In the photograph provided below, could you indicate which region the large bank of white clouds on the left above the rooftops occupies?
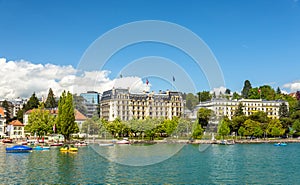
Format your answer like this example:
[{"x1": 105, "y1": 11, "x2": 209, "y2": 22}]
[{"x1": 0, "y1": 58, "x2": 150, "y2": 99}]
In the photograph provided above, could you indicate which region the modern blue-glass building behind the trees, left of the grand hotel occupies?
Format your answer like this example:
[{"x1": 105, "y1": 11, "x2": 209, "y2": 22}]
[{"x1": 80, "y1": 91, "x2": 100, "y2": 118}]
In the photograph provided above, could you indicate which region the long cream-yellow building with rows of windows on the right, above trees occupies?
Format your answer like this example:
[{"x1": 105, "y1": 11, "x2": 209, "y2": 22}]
[{"x1": 194, "y1": 99, "x2": 289, "y2": 119}]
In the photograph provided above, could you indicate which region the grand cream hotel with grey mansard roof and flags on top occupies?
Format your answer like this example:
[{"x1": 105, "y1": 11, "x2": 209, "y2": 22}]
[{"x1": 100, "y1": 88, "x2": 183, "y2": 121}]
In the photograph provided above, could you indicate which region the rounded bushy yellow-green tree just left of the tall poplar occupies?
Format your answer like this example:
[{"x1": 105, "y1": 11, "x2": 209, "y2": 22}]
[{"x1": 25, "y1": 105, "x2": 55, "y2": 137}]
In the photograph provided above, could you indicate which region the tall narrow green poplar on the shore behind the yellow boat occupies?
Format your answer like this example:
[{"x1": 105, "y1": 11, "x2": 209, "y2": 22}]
[{"x1": 56, "y1": 91, "x2": 79, "y2": 140}]
